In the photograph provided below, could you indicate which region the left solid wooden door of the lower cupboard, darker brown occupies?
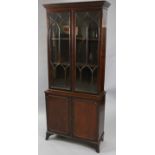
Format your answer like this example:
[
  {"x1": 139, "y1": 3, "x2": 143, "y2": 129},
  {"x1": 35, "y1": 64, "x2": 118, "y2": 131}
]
[{"x1": 46, "y1": 95, "x2": 69, "y2": 134}]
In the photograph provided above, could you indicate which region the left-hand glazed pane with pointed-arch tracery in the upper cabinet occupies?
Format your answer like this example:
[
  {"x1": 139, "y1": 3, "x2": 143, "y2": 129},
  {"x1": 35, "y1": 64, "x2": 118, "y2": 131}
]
[{"x1": 48, "y1": 12, "x2": 70, "y2": 89}]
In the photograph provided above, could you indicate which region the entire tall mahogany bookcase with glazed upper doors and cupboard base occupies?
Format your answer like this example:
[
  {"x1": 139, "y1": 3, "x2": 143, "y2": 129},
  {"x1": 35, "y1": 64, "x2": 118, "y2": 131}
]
[{"x1": 44, "y1": 1, "x2": 110, "y2": 152}]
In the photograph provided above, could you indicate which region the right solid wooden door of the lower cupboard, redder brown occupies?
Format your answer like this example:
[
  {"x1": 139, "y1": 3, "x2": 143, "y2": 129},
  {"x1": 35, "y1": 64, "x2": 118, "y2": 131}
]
[{"x1": 73, "y1": 99, "x2": 97, "y2": 140}]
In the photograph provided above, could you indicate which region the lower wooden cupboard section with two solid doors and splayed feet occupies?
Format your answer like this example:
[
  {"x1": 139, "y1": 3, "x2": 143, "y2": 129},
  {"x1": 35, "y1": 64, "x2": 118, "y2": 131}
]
[{"x1": 45, "y1": 91, "x2": 105, "y2": 152}]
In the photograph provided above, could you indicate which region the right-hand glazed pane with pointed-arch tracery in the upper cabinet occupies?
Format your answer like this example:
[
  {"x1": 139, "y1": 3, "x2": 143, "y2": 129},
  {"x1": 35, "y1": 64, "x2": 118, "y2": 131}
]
[{"x1": 75, "y1": 11, "x2": 99, "y2": 93}]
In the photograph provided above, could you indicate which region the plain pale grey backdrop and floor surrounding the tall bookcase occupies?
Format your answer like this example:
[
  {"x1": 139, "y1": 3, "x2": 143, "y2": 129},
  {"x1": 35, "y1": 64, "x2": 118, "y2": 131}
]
[{"x1": 38, "y1": 0, "x2": 116, "y2": 155}]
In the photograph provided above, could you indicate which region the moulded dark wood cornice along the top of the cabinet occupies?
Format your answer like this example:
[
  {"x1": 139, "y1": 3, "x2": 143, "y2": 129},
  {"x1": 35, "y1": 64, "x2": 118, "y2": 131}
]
[{"x1": 43, "y1": 1, "x2": 110, "y2": 9}]
